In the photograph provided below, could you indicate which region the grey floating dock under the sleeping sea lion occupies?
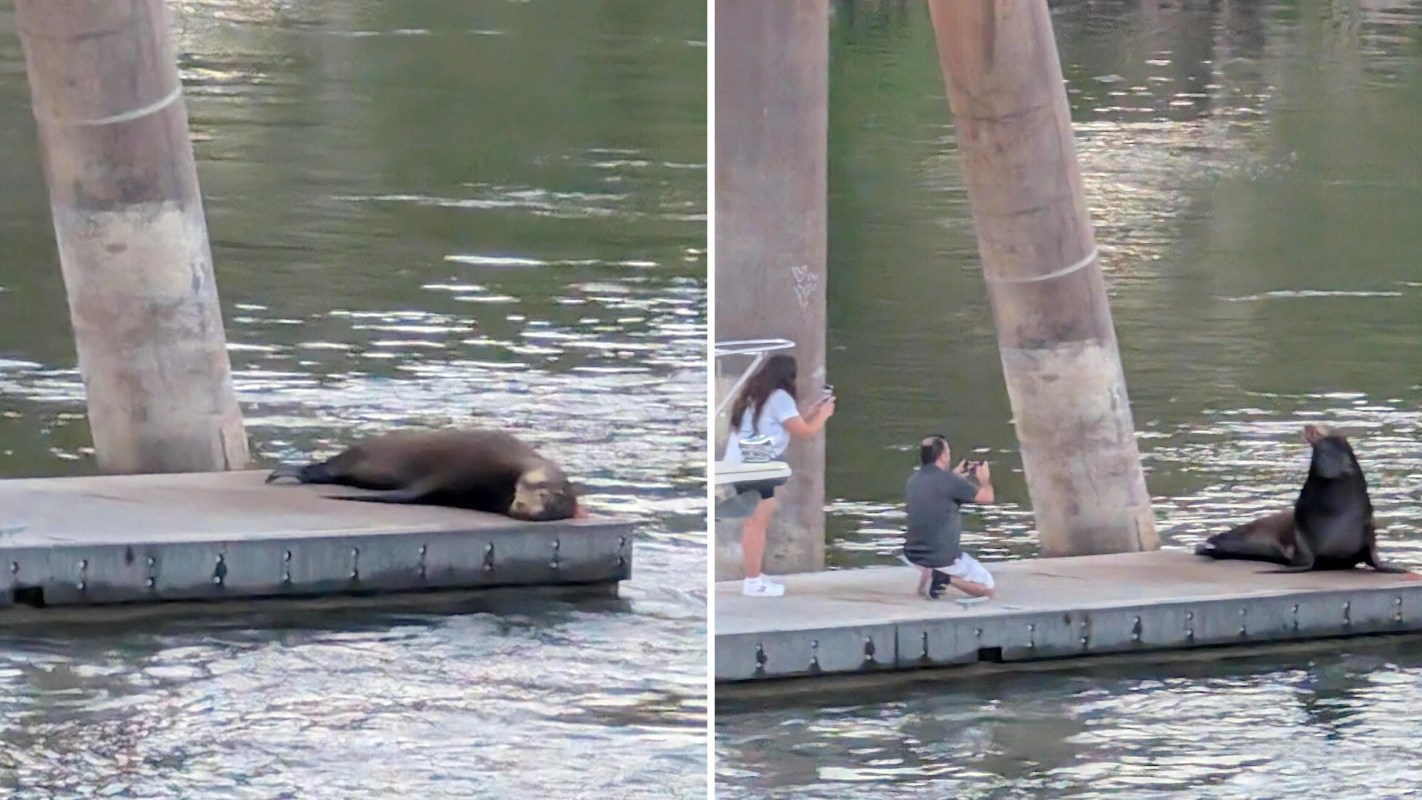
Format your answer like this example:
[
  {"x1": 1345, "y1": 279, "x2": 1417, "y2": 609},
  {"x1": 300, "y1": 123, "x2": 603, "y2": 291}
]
[{"x1": 0, "y1": 472, "x2": 633, "y2": 611}]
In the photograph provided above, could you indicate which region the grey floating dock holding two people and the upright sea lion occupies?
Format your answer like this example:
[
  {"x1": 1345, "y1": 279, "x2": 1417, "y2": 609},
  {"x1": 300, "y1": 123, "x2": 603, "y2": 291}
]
[{"x1": 715, "y1": 550, "x2": 1422, "y2": 683}]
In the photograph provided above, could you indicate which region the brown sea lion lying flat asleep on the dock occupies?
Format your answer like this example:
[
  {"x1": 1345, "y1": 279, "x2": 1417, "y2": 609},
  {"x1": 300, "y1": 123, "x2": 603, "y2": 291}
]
[{"x1": 266, "y1": 429, "x2": 587, "y2": 521}]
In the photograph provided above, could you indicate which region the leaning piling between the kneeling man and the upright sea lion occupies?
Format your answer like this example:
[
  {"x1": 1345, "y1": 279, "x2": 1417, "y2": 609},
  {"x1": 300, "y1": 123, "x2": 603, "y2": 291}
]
[{"x1": 929, "y1": 0, "x2": 1159, "y2": 556}]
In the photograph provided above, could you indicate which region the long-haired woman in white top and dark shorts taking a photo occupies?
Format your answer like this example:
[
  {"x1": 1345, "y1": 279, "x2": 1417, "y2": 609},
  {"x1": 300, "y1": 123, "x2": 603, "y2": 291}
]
[{"x1": 725, "y1": 354, "x2": 835, "y2": 597}]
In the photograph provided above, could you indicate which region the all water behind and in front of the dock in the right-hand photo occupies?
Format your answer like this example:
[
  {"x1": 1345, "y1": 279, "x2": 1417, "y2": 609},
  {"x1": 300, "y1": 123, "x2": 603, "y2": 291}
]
[{"x1": 717, "y1": 0, "x2": 1422, "y2": 799}]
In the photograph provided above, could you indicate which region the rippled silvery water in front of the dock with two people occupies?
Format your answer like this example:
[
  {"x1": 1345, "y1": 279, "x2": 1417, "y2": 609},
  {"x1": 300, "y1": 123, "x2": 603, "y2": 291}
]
[{"x1": 717, "y1": 641, "x2": 1422, "y2": 799}]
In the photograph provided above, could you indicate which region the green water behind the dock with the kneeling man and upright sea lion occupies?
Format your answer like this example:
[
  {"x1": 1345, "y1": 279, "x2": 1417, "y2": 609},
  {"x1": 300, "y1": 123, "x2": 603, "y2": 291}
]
[{"x1": 826, "y1": 1, "x2": 1422, "y2": 566}]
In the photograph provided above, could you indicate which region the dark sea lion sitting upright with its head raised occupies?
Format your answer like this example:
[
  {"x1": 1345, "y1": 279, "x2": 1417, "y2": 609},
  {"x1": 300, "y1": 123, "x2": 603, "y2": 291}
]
[{"x1": 1194, "y1": 423, "x2": 1409, "y2": 573}]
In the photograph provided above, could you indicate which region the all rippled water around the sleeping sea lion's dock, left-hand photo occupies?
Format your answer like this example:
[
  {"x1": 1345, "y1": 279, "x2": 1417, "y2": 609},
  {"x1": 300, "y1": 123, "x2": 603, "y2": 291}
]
[{"x1": 0, "y1": 0, "x2": 707, "y2": 799}]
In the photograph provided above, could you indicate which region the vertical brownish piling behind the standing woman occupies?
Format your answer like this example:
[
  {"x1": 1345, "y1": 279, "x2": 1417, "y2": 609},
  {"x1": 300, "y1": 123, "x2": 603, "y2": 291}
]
[{"x1": 715, "y1": 0, "x2": 833, "y2": 580}]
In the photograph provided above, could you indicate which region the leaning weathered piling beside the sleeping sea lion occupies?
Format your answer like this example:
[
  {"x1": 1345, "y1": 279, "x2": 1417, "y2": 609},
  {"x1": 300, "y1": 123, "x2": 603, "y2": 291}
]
[{"x1": 16, "y1": 0, "x2": 247, "y2": 473}]
